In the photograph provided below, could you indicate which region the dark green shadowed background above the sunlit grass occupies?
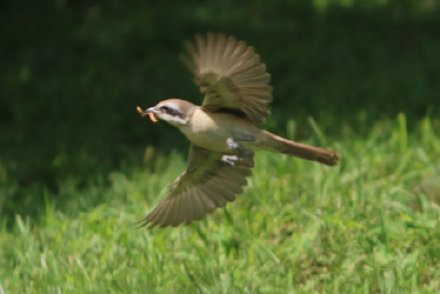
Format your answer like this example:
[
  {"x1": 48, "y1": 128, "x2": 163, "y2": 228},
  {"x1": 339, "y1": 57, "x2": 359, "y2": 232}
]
[{"x1": 0, "y1": 0, "x2": 440, "y2": 224}]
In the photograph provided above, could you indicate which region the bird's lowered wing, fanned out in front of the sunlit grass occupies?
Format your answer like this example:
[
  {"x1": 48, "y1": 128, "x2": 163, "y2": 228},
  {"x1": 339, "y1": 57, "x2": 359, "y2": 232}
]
[{"x1": 141, "y1": 145, "x2": 254, "y2": 227}]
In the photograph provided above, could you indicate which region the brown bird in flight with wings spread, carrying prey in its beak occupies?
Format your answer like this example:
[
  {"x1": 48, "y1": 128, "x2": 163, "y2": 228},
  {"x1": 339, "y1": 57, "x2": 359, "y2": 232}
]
[{"x1": 137, "y1": 33, "x2": 340, "y2": 228}]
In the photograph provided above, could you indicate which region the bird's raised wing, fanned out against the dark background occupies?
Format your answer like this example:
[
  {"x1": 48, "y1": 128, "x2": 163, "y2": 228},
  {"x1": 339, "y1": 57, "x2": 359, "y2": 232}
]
[{"x1": 183, "y1": 34, "x2": 272, "y2": 123}]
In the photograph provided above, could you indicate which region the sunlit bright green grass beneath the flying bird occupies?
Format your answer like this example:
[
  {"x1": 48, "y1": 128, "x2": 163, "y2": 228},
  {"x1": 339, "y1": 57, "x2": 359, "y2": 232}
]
[{"x1": 0, "y1": 115, "x2": 440, "y2": 293}]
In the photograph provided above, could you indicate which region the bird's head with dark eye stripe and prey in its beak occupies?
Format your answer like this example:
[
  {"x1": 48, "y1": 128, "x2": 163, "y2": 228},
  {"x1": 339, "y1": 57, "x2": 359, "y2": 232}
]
[{"x1": 137, "y1": 98, "x2": 194, "y2": 127}]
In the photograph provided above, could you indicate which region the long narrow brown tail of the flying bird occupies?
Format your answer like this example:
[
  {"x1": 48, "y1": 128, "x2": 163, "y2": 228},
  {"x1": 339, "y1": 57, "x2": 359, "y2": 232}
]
[{"x1": 261, "y1": 131, "x2": 340, "y2": 165}]
